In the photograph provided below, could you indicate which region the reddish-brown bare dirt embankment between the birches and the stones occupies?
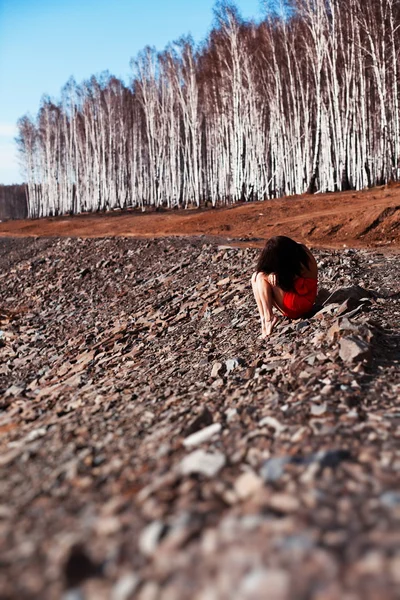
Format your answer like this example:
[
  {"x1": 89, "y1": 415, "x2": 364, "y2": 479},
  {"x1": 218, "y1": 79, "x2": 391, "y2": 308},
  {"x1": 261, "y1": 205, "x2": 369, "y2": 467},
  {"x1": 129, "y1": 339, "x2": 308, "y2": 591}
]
[{"x1": 0, "y1": 184, "x2": 400, "y2": 247}]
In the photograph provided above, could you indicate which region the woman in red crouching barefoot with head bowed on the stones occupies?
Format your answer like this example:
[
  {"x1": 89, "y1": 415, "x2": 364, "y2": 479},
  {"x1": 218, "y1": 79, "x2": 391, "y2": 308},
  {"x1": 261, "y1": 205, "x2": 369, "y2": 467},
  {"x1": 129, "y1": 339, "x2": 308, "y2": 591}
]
[{"x1": 251, "y1": 235, "x2": 318, "y2": 338}]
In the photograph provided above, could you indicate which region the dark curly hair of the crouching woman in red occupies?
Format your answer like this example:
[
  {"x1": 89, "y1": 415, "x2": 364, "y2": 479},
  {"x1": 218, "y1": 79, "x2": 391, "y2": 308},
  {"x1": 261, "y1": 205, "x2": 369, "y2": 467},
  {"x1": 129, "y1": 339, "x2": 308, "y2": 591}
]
[{"x1": 257, "y1": 235, "x2": 310, "y2": 292}]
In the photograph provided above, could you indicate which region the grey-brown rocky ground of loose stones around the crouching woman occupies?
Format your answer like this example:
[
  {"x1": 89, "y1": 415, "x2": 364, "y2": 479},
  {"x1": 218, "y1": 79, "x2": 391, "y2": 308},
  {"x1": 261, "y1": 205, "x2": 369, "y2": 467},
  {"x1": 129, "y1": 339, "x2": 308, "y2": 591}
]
[{"x1": 0, "y1": 238, "x2": 400, "y2": 600}]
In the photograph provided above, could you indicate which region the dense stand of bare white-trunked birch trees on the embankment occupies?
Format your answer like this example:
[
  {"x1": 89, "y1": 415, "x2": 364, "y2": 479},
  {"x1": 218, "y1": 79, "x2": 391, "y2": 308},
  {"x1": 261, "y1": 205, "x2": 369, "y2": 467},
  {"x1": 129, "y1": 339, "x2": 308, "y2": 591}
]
[{"x1": 18, "y1": 0, "x2": 400, "y2": 217}]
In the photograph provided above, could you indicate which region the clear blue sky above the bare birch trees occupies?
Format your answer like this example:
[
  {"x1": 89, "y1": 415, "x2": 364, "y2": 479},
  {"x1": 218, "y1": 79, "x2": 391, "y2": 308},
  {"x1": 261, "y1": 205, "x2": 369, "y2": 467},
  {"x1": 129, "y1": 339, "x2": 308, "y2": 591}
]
[{"x1": 0, "y1": 0, "x2": 262, "y2": 184}]
